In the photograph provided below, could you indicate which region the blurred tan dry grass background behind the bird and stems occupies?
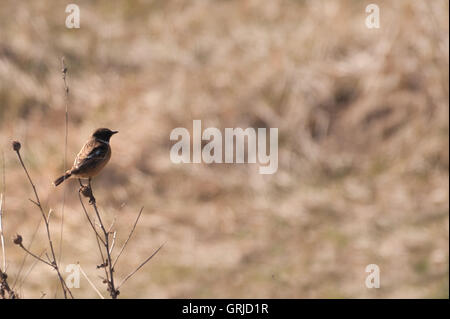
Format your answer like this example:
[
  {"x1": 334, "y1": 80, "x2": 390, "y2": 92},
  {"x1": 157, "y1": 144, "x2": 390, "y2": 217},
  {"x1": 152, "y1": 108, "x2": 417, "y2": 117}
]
[{"x1": 0, "y1": 0, "x2": 449, "y2": 298}]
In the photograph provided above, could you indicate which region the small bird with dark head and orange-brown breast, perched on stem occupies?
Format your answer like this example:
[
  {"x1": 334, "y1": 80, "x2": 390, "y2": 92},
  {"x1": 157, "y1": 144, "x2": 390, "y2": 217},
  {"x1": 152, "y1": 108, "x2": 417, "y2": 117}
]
[{"x1": 53, "y1": 128, "x2": 118, "y2": 187}]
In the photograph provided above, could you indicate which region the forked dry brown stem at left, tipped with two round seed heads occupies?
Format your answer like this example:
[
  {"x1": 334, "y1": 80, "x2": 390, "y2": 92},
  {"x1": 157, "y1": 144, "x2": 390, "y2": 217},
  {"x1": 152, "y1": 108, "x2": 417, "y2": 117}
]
[{"x1": 14, "y1": 149, "x2": 73, "y2": 299}]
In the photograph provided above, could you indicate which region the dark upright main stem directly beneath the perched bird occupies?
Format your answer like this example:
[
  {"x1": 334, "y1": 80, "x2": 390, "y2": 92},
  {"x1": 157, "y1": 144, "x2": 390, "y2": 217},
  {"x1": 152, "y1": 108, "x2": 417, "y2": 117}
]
[{"x1": 79, "y1": 179, "x2": 119, "y2": 299}]
